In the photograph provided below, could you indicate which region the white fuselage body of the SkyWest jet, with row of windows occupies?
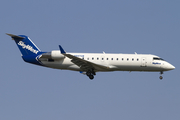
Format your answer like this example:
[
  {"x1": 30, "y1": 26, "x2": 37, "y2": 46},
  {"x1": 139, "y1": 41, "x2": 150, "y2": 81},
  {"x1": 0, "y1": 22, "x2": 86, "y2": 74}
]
[{"x1": 40, "y1": 51, "x2": 174, "y2": 72}]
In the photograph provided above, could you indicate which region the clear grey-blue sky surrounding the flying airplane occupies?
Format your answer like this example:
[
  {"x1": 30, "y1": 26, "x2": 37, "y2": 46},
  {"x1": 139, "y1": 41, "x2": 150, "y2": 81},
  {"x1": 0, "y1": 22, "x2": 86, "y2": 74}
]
[{"x1": 0, "y1": 0, "x2": 180, "y2": 120}]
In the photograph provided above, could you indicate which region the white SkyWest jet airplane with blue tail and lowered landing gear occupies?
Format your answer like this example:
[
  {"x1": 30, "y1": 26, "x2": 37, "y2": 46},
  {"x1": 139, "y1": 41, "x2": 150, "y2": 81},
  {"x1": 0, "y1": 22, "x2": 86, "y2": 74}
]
[{"x1": 6, "y1": 33, "x2": 175, "y2": 80}]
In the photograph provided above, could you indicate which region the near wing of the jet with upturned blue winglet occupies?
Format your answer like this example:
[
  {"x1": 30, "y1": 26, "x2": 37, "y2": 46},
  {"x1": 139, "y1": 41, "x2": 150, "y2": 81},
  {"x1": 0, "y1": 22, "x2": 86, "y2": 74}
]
[{"x1": 59, "y1": 45, "x2": 109, "y2": 71}]
